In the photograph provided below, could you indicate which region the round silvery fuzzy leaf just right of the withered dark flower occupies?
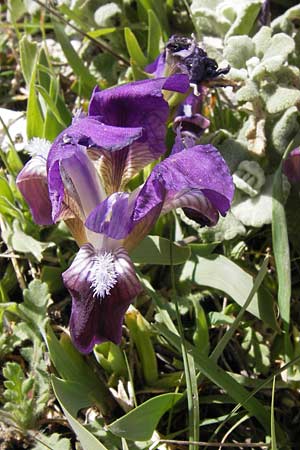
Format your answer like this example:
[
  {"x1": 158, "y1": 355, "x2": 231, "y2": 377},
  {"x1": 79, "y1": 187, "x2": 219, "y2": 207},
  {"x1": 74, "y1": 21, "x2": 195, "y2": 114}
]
[{"x1": 224, "y1": 36, "x2": 255, "y2": 69}]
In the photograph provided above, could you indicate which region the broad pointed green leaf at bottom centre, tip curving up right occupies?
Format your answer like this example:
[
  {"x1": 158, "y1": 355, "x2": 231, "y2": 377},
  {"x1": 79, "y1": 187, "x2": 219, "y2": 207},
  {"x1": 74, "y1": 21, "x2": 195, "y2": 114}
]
[{"x1": 108, "y1": 393, "x2": 182, "y2": 441}]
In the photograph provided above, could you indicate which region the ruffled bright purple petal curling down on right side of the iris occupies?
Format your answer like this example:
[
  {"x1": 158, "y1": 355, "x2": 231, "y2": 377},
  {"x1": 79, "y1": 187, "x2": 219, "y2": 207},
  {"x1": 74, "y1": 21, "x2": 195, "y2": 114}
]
[{"x1": 133, "y1": 145, "x2": 234, "y2": 224}]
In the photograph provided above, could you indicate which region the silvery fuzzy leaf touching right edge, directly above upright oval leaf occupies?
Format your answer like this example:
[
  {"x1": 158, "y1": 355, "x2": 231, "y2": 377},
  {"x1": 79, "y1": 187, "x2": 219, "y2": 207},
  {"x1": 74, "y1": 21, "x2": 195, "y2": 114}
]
[{"x1": 262, "y1": 86, "x2": 300, "y2": 114}]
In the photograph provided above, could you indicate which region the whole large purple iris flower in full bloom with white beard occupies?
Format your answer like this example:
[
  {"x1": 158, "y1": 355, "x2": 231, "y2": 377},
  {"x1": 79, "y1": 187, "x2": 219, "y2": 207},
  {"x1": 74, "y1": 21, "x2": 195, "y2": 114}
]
[{"x1": 17, "y1": 75, "x2": 233, "y2": 353}]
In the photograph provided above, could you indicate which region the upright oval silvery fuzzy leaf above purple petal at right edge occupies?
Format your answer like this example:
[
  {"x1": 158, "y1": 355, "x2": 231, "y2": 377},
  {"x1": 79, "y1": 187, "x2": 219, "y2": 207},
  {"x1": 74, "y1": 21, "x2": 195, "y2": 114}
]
[{"x1": 271, "y1": 106, "x2": 299, "y2": 155}]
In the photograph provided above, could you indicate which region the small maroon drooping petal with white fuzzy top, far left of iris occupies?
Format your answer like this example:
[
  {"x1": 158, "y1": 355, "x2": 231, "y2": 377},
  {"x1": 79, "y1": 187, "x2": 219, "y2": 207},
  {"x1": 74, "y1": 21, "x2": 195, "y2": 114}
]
[{"x1": 17, "y1": 156, "x2": 53, "y2": 225}]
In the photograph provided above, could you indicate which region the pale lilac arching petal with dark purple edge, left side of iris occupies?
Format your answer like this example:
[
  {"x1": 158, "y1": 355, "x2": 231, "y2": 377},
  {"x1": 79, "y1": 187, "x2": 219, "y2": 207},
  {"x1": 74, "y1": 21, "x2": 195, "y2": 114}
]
[{"x1": 47, "y1": 137, "x2": 105, "y2": 221}]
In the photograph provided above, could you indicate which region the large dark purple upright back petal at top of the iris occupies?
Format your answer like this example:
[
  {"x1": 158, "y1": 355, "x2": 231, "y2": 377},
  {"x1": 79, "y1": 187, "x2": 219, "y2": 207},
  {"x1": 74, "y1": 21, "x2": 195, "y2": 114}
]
[{"x1": 86, "y1": 74, "x2": 189, "y2": 194}]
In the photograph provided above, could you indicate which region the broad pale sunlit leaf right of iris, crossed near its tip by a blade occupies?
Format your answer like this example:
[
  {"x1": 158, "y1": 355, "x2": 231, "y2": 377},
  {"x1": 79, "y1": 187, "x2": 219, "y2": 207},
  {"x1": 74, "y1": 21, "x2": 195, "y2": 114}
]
[{"x1": 181, "y1": 254, "x2": 278, "y2": 330}]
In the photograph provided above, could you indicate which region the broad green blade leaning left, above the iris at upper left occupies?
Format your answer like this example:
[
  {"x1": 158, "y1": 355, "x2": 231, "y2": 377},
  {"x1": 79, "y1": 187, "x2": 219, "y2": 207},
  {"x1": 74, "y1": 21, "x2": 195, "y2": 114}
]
[{"x1": 52, "y1": 19, "x2": 97, "y2": 98}]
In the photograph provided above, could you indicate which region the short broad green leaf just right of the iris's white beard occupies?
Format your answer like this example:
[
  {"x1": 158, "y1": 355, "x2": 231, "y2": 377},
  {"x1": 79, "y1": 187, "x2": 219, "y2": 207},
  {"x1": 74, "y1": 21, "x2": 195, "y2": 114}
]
[{"x1": 130, "y1": 236, "x2": 191, "y2": 265}]
